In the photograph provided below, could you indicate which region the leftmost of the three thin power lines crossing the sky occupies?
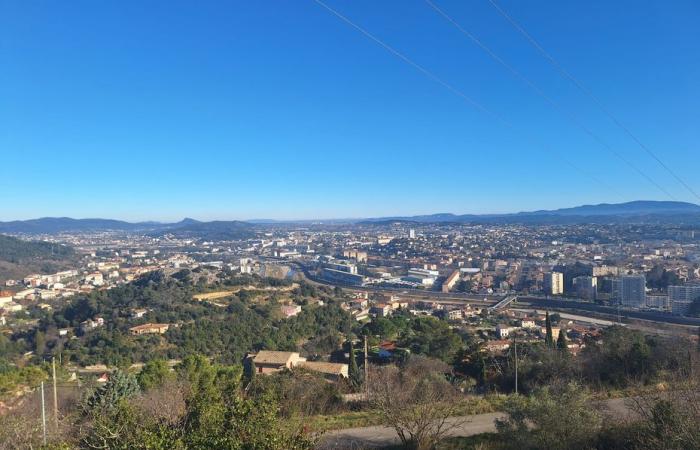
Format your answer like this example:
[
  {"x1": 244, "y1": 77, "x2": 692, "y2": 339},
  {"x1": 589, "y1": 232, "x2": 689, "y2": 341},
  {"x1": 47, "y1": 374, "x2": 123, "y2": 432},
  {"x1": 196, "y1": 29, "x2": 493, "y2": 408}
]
[{"x1": 314, "y1": 0, "x2": 624, "y2": 198}]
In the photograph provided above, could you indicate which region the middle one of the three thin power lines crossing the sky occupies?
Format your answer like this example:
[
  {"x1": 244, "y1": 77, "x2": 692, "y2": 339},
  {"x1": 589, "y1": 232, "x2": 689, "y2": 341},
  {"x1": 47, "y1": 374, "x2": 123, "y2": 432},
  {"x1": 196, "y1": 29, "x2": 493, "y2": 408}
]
[{"x1": 425, "y1": 0, "x2": 675, "y2": 200}]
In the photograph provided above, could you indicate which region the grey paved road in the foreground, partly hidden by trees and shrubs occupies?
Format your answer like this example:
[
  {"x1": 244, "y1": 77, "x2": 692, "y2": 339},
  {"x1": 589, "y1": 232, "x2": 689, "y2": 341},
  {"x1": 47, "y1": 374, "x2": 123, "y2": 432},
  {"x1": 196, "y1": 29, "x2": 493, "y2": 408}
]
[{"x1": 318, "y1": 399, "x2": 633, "y2": 450}]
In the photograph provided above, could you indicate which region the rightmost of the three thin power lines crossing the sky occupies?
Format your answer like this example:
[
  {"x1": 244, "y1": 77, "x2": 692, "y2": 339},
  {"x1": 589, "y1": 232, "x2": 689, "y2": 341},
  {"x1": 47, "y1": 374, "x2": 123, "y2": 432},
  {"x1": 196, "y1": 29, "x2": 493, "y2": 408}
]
[{"x1": 488, "y1": 0, "x2": 700, "y2": 200}]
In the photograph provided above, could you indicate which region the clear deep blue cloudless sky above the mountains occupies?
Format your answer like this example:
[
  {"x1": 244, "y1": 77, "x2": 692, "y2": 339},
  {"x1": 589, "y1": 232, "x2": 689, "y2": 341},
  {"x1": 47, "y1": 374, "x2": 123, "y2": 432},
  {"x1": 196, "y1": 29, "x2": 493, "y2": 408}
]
[{"x1": 0, "y1": 0, "x2": 700, "y2": 220}]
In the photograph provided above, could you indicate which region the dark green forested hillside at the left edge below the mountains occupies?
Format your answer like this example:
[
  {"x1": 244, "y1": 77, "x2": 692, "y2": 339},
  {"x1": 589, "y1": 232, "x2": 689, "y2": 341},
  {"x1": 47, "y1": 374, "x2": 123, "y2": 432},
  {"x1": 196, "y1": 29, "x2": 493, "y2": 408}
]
[{"x1": 0, "y1": 234, "x2": 77, "y2": 282}]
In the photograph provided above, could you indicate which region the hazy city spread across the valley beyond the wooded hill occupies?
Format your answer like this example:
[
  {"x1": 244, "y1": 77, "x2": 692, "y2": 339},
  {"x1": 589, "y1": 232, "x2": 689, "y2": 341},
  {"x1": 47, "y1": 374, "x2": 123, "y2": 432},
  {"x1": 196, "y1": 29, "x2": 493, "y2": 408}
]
[{"x1": 0, "y1": 202, "x2": 700, "y2": 324}]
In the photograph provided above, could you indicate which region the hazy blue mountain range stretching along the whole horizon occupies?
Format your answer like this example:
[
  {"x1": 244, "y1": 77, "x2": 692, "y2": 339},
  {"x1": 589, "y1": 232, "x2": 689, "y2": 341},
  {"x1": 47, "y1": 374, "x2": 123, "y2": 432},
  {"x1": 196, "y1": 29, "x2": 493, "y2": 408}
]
[{"x1": 0, "y1": 200, "x2": 700, "y2": 236}]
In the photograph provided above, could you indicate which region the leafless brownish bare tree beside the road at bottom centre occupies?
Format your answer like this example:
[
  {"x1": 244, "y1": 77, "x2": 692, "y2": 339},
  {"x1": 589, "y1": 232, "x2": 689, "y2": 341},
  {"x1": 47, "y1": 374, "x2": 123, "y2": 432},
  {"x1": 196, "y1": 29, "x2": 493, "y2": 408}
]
[{"x1": 369, "y1": 356, "x2": 465, "y2": 450}]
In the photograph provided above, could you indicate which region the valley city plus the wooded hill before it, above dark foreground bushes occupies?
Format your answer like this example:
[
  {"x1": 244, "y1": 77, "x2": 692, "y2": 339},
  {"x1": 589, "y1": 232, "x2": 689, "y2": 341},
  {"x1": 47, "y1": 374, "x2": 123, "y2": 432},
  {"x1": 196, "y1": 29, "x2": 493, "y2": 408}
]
[{"x1": 0, "y1": 208, "x2": 700, "y2": 428}]
